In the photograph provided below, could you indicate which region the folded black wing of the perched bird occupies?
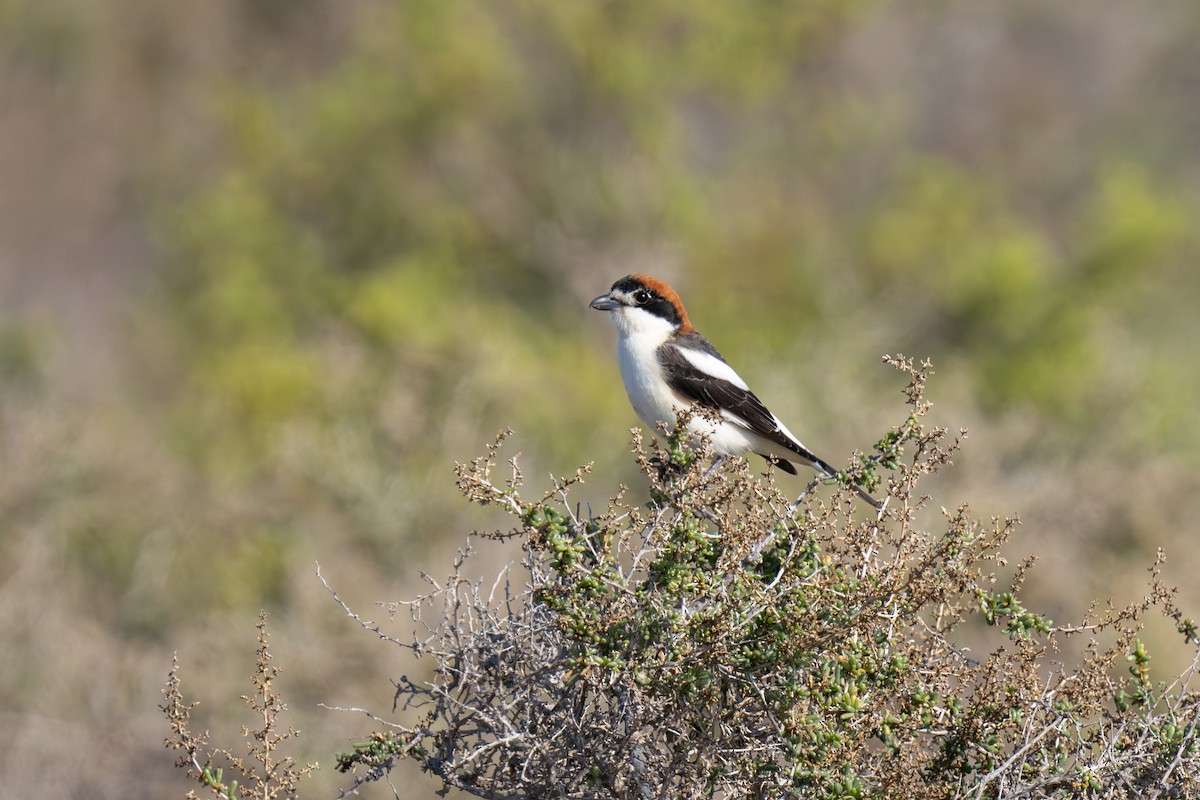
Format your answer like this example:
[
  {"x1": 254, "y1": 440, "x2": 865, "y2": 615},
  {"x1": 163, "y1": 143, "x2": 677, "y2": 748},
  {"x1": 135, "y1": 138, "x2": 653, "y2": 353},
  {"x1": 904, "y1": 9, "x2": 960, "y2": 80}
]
[{"x1": 659, "y1": 331, "x2": 836, "y2": 475}]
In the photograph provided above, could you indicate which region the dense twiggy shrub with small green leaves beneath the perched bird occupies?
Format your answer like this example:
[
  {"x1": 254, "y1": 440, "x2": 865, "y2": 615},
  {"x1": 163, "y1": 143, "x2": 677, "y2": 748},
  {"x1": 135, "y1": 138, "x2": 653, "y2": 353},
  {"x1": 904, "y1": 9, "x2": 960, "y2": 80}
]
[{"x1": 324, "y1": 357, "x2": 1200, "y2": 800}]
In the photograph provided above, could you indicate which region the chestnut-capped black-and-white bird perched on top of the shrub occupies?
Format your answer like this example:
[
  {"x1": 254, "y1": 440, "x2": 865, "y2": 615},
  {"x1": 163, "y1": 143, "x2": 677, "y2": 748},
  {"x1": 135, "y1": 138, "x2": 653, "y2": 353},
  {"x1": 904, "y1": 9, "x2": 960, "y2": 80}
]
[{"x1": 590, "y1": 273, "x2": 883, "y2": 510}]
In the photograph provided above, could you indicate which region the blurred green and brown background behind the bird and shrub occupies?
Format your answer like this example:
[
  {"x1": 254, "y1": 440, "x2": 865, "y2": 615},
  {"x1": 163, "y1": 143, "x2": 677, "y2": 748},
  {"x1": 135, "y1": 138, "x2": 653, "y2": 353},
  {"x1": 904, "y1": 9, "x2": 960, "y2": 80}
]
[{"x1": 0, "y1": 0, "x2": 1200, "y2": 799}]
